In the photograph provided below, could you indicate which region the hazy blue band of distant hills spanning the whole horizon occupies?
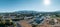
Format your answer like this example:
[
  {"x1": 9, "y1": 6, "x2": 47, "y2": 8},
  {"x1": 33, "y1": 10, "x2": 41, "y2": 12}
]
[{"x1": 0, "y1": 10, "x2": 60, "y2": 14}]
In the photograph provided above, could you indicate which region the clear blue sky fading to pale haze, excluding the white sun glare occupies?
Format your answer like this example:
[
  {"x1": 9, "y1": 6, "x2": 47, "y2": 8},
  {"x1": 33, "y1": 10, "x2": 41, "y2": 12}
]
[{"x1": 0, "y1": 0, "x2": 60, "y2": 12}]
